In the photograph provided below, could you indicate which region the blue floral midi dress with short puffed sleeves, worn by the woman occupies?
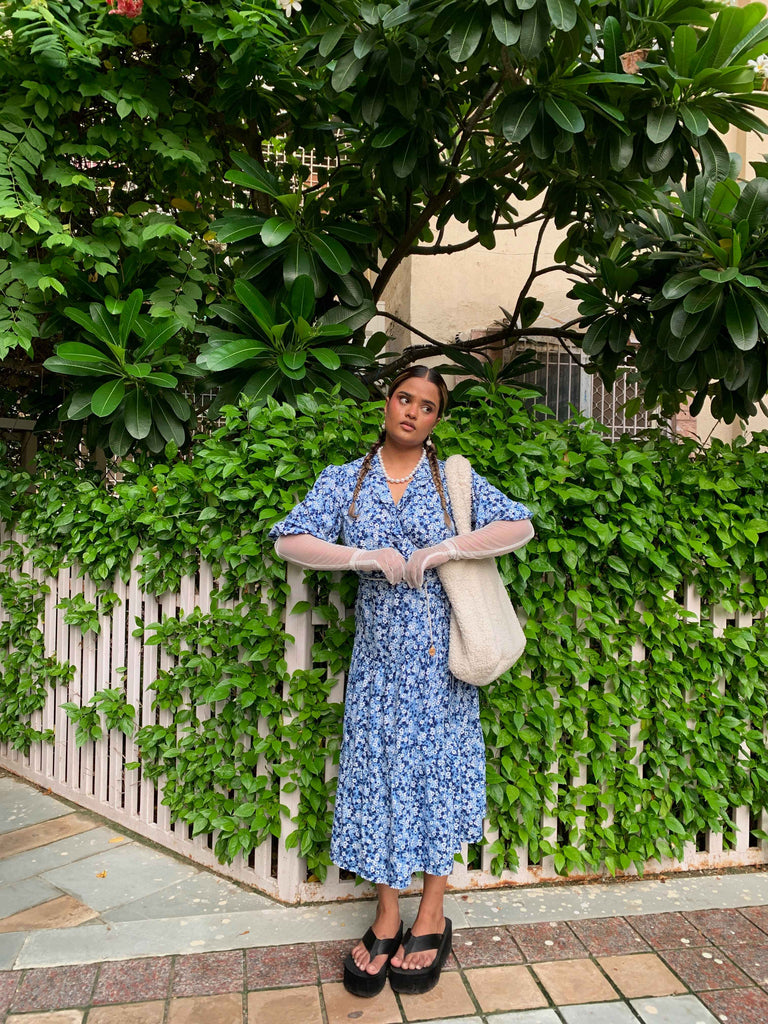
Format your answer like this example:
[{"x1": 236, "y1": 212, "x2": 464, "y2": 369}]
[{"x1": 269, "y1": 459, "x2": 531, "y2": 889}]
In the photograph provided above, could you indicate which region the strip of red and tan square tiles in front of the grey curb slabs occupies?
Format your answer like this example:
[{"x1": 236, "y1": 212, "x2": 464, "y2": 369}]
[{"x1": 0, "y1": 906, "x2": 768, "y2": 1024}]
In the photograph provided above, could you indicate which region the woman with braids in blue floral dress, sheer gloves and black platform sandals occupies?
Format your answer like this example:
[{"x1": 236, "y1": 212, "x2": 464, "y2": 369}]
[{"x1": 270, "y1": 366, "x2": 534, "y2": 995}]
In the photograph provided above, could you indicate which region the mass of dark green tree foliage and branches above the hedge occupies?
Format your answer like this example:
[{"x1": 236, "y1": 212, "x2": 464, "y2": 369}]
[{"x1": 0, "y1": 0, "x2": 768, "y2": 449}]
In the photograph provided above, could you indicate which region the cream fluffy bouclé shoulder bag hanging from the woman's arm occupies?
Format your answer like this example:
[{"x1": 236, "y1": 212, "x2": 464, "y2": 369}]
[{"x1": 437, "y1": 455, "x2": 525, "y2": 686}]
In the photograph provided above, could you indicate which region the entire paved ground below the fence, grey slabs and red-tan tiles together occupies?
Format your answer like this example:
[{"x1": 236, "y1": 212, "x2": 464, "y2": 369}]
[{"x1": 0, "y1": 770, "x2": 768, "y2": 1024}]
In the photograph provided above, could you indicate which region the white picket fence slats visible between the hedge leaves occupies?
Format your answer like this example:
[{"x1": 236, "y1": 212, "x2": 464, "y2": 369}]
[{"x1": 0, "y1": 531, "x2": 768, "y2": 902}]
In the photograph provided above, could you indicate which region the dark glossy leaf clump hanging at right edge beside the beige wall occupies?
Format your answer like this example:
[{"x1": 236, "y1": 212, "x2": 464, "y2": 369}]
[{"x1": 571, "y1": 175, "x2": 768, "y2": 423}]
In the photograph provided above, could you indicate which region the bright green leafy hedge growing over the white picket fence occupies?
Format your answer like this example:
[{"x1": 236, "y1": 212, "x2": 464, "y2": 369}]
[{"x1": 0, "y1": 394, "x2": 768, "y2": 879}]
